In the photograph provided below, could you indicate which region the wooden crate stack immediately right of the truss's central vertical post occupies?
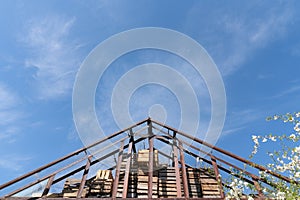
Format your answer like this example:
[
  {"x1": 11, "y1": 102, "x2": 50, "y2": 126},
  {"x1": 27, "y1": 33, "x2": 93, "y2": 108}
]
[{"x1": 158, "y1": 167, "x2": 181, "y2": 198}]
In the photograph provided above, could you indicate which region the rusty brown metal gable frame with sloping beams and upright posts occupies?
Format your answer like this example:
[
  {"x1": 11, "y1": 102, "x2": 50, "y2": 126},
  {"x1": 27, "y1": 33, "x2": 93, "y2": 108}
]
[{"x1": 0, "y1": 118, "x2": 298, "y2": 200}]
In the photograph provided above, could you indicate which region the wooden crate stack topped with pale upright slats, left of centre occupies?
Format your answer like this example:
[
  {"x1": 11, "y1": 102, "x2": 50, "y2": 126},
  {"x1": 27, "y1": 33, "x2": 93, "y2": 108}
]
[{"x1": 88, "y1": 170, "x2": 114, "y2": 197}]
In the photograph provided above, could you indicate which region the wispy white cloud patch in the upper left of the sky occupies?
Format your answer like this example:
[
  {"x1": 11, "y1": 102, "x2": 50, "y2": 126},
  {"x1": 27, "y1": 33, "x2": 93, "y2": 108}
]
[{"x1": 22, "y1": 16, "x2": 80, "y2": 99}]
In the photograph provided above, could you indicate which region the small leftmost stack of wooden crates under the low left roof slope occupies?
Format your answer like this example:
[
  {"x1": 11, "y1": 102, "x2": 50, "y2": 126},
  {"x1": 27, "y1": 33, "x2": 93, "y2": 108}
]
[{"x1": 62, "y1": 178, "x2": 87, "y2": 198}]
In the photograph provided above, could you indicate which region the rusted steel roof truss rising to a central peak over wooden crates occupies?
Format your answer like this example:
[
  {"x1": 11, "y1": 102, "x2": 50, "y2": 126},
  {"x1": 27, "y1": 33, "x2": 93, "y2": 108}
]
[{"x1": 0, "y1": 118, "x2": 292, "y2": 200}]
